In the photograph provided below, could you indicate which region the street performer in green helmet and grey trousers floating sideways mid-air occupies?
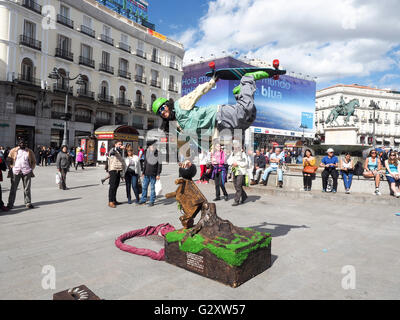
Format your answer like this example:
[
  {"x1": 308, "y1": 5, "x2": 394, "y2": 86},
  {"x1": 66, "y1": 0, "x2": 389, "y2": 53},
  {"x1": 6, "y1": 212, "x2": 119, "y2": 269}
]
[{"x1": 152, "y1": 71, "x2": 269, "y2": 136}]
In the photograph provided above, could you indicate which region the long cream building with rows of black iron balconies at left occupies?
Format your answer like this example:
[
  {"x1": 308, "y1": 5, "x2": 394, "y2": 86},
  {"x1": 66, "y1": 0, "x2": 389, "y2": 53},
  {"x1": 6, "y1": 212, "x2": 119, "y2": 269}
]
[{"x1": 0, "y1": 0, "x2": 184, "y2": 146}]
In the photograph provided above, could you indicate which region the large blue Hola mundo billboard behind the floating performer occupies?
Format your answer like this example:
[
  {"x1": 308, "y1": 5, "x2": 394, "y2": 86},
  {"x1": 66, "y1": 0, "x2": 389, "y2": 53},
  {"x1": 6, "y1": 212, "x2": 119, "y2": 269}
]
[{"x1": 182, "y1": 57, "x2": 316, "y2": 137}]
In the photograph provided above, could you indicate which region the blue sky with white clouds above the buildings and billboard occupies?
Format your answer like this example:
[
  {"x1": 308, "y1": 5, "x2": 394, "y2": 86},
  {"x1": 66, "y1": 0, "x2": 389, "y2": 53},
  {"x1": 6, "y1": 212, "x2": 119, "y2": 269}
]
[{"x1": 149, "y1": 0, "x2": 400, "y2": 91}]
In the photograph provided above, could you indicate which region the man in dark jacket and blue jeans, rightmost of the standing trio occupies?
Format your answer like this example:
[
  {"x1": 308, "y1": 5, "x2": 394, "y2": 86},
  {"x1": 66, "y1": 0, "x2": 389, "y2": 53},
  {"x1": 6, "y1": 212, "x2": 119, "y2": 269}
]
[{"x1": 139, "y1": 141, "x2": 162, "y2": 207}]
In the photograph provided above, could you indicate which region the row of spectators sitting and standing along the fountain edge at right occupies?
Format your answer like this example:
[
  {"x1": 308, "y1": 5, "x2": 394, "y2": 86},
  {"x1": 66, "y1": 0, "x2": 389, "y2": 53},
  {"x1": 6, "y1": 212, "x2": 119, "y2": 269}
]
[{"x1": 189, "y1": 144, "x2": 400, "y2": 205}]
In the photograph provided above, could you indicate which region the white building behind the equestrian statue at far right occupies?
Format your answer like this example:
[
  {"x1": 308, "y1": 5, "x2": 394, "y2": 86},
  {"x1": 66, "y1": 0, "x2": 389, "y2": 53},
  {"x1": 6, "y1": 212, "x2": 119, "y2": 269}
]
[{"x1": 315, "y1": 84, "x2": 400, "y2": 149}]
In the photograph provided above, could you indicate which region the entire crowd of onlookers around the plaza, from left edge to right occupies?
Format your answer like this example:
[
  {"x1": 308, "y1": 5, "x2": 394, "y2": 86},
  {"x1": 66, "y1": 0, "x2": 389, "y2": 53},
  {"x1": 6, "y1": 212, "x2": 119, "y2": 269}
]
[{"x1": 0, "y1": 139, "x2": 400, "y2": 211}]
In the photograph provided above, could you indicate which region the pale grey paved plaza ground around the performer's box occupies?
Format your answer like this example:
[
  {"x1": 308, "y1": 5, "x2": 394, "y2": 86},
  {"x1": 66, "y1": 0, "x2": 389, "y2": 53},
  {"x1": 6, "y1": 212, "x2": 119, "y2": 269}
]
[{"x1": 0, "y1": 165, "x2": 400, "y2": 300}]
